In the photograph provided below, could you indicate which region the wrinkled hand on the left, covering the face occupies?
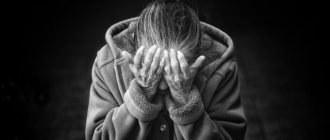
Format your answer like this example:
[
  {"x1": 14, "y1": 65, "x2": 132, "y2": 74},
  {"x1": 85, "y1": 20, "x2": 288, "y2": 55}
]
[{"x1": 122, "y1": 45, "x2": 165, "y2": 100}]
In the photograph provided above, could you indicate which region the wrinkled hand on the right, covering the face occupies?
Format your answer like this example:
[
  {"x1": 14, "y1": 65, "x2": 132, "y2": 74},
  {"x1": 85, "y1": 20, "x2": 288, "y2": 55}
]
[{"x1": 164, "y1": 49, "x2": 205, "y2": 103}]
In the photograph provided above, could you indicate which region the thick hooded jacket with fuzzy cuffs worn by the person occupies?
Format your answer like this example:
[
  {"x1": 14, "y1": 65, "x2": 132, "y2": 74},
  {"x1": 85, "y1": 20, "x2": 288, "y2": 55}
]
[{"x1": 86, "y1": 18, "x2": 246, "y2": 140}]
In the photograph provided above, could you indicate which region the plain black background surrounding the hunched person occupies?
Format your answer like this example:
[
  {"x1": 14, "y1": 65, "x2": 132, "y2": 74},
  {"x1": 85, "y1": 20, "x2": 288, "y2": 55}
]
[{"x1": 0, "y1": 0, "x2": 329, "y2": 140}]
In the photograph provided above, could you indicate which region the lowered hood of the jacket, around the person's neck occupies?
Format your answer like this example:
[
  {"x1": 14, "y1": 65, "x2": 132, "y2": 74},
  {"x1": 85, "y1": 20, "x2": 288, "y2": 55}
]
[{"x1": 105, "y1": 17, "x2": 234, "y2": 79}]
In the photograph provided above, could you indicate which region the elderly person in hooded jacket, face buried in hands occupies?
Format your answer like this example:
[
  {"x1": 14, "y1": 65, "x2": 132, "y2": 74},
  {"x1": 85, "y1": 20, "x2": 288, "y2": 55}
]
[{"x1": 86, "y1": 1, "x2": 246, "y2": 140}]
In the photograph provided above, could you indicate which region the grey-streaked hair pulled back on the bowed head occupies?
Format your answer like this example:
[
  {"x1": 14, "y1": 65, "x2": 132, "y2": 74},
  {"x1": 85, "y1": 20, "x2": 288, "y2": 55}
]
[{"x1": 134, "y1": 0, "x2": 202, "y2": 62}]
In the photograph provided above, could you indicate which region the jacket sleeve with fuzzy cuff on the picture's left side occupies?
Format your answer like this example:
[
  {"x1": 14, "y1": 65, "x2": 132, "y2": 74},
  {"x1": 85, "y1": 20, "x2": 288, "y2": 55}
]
[{"x1": 85, "y1": 57, "x2": 163, "y2": 140}]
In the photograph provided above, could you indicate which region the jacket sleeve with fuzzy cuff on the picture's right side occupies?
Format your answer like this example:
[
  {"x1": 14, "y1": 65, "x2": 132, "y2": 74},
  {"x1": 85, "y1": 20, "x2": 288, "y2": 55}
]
[{"x1": 165, "y1": 61, "x2": 246, "y2": 140}]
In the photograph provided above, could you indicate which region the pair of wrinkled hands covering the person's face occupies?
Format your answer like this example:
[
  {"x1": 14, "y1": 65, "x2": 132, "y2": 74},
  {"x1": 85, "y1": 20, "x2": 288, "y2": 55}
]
[{"x1": 122, "y1": 45, "x2": 205, "y2": 104}]
